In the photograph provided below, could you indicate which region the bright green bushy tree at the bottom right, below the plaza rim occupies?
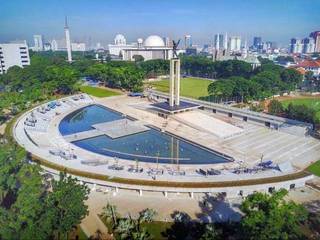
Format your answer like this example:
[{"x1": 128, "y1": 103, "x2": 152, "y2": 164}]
[{"x1": 240, "y1": 190, "x2": 307, "y2": 240}]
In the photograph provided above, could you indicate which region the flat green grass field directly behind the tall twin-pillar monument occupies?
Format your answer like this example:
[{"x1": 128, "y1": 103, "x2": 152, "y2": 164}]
[{"x1": 148, "y1": 78, "x2": 212, "y2": 99}]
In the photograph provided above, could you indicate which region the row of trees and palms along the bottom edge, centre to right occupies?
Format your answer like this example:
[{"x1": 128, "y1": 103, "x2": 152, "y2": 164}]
[{"x1": 102, "y1": 190, "x2": 311, "y2": 240}]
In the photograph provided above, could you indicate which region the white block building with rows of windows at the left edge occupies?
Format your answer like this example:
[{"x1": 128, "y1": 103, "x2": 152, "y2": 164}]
[{"x1": 0, "y1": 42, "x2": 30, "y2": 74}]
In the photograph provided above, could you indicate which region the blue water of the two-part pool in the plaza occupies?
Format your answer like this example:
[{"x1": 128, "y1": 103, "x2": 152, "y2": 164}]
[{"x1": 59, "y1": 105, "x2": 229, "y2": 164}]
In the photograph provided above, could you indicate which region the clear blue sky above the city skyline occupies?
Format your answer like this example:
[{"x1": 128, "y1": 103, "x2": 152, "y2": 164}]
[{"x1": 0, "y1": 0, "x2": 320, "y2": 45}]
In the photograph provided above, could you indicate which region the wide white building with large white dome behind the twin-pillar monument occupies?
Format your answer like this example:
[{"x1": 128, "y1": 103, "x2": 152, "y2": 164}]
[{"x1": 122, "y1": 35, "x2": 173, "y2": 61}]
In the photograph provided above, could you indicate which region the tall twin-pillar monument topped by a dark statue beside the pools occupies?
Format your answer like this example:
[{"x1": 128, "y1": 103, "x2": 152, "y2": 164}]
[{"x1": 169, "y1": 40, "x2": 180, "y2": 107}]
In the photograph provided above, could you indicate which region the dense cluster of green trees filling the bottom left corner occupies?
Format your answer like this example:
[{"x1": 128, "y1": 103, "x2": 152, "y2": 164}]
[{"x1": 0, "y1": 142, "x2": 89, "y2": 239}]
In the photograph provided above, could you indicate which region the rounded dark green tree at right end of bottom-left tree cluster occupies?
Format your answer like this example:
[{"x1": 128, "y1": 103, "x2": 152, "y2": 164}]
[{"x1": 46, "y1": 173, "x2": 89, "y2": 239}]
